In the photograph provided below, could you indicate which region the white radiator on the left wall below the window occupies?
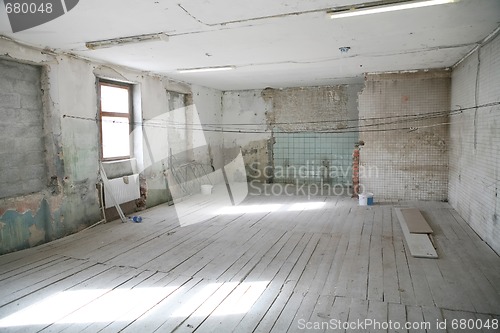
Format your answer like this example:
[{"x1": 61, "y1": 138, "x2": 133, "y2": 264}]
[{"x1": 104, "y1": 174, "x2": 141, "y2": 208}]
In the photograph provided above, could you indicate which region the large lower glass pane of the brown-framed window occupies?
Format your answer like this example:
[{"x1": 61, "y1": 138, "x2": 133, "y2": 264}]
[{"x1": 102, "y1": 117, "x2": 130, "y2": 158}]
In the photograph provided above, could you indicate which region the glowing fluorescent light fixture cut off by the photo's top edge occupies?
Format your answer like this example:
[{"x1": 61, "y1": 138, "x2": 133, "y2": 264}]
[{"x1": 328, "y1": 0, "x2": 458, "y2": 19}]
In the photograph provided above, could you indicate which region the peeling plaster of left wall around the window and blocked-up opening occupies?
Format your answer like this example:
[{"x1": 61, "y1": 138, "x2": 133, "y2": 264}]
[{"x1": 0, "y1": 39, "x2": 222, "y2": 254}]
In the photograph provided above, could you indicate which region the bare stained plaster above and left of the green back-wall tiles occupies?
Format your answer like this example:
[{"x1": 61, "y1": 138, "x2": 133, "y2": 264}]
[{"x1": 222, "y1": 85, "x2": 362, "y2": 182}]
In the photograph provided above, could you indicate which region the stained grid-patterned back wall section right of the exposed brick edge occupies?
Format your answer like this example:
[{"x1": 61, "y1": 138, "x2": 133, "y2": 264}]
[{"x1": 359, "y1": 71, "x2": 450, "y2": 201}]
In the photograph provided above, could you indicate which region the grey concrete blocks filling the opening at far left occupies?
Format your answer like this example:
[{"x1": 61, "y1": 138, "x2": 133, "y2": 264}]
[{"x1": 0, "y1": 60, "x2": 47, "y2": 198}]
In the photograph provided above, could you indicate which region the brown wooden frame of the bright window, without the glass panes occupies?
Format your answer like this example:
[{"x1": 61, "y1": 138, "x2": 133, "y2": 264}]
[{"x1": 97, "y1": 79, "x2": 133, "y2": 161}]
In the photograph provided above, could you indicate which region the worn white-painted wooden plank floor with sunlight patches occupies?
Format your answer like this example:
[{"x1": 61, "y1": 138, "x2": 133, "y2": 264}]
[{"x1": 0, "y1": 192, "x2": 500, "y2": 332}]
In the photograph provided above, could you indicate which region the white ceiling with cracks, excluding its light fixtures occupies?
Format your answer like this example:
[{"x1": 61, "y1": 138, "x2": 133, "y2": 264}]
[{"x1": 0, "y1": 0, "x2": 500, "y2": 90}]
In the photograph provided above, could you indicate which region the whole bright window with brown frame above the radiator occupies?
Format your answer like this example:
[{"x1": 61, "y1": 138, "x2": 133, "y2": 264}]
[{"x1": 99, "y1": 81, "x2": 132, "y2": 160}]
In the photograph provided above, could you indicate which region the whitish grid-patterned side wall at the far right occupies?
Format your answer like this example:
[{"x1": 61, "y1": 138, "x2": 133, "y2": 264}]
[{"x1": 448, "y1": 31, "x2": 500, "y2": 253}]
